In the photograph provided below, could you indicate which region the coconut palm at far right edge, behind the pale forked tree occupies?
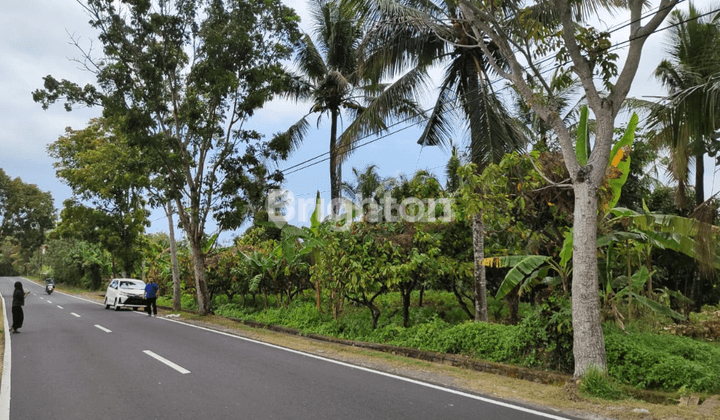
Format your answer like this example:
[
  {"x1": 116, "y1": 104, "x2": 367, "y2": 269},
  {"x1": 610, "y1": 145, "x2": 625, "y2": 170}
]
[{"x1": 649, "y1": 3, "x2": 720, "y2": 207}]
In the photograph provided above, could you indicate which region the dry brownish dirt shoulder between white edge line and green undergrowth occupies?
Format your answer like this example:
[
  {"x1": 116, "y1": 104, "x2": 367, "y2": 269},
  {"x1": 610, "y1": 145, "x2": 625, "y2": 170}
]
[{"x1": 19, "y1": 292, "x2": 720, "y2": 420}]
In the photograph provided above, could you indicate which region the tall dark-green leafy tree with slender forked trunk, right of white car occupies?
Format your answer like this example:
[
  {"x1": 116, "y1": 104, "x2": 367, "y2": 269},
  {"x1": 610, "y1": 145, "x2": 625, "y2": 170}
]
[{"x1": 33, "y1": 0, "x2": 298, "y2": 314}]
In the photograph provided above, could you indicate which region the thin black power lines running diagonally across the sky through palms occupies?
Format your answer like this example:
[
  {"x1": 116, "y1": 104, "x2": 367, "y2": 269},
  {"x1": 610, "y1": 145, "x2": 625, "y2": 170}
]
[{"x1": 280, "y1": 0, "x2": 720, "y2": 175}]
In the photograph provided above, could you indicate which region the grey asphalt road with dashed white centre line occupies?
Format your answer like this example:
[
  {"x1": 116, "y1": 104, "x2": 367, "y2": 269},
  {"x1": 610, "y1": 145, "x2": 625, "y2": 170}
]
[{"x1": 0, "y1": 277, "x2": 565, "y2": 420}]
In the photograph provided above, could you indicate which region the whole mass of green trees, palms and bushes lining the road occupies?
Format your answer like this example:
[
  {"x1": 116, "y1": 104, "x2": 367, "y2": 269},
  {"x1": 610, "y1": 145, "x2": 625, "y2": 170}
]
[{"x1": 0, "y1": 0, "x2": 720, "y2": 406}]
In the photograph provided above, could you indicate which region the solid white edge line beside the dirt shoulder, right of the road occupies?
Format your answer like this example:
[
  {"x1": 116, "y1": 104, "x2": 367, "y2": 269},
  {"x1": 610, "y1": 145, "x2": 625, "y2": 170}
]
[{"x1": 50, "y1": 282, "x2": 569, "y2": 420}]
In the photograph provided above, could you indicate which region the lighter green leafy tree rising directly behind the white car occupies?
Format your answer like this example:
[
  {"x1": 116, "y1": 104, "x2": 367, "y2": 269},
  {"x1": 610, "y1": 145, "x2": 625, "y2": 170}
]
[{"x1": 48, "y1": 119, "x2": 150, "y2": 276}]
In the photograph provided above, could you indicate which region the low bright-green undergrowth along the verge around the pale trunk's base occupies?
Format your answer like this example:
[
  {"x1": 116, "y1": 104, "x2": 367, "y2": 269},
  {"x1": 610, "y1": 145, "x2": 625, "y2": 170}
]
[{"x1": 216, "y1": 299, "x2": 720, "y2": 393}]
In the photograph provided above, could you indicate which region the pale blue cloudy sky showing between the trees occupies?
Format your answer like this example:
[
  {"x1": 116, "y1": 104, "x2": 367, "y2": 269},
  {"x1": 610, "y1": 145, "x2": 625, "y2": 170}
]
[{"x1": 0, "y1": 0, "x2": 717, "y2": 243}]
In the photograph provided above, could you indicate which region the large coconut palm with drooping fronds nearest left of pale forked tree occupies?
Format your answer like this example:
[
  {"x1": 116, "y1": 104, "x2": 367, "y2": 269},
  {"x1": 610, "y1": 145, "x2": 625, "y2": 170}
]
[{"x1": 361, "y1": 0, "x2": 526, "y2": 321}]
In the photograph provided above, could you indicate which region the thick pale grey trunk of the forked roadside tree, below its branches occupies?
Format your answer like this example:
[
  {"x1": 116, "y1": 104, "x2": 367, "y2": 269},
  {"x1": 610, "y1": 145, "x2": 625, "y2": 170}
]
[{"x1": 572, "y1": 180, "x2": 607, "y2": 378}]
